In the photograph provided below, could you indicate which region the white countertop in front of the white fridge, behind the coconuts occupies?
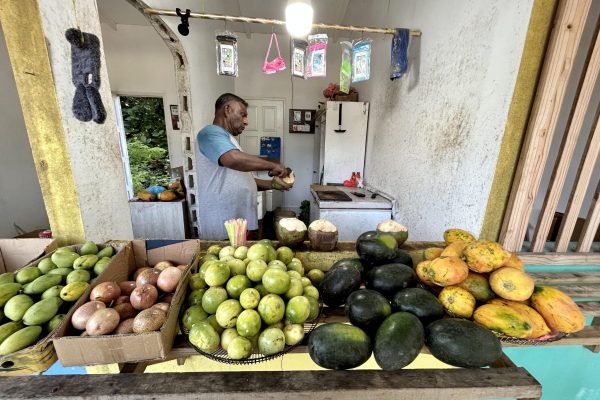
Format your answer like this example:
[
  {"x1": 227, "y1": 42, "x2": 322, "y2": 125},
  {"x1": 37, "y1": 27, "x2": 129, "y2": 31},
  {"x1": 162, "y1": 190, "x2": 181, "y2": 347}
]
[{"x1": 310, "y1": 185, "x2": 392, "y2": 210}]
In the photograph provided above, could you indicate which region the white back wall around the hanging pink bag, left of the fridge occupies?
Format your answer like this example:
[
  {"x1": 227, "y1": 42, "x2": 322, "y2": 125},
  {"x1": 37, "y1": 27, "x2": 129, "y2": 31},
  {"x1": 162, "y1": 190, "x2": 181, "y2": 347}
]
[{"x1": 235, "y1": 33, "x2": 341, "y2": 210}]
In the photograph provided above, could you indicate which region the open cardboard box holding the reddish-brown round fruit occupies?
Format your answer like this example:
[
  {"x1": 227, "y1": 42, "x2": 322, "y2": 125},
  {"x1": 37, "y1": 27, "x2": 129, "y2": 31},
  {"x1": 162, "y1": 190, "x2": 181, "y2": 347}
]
[{"x1": 54, "y1": 240, "x2": 200, "y2": 366}]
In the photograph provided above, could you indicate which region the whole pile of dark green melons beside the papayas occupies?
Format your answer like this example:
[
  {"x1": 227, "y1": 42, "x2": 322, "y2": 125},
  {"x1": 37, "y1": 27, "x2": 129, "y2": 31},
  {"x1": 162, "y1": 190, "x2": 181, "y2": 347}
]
[{"x1": 308, "y1": 231, "x2": 502, "y2": 371}]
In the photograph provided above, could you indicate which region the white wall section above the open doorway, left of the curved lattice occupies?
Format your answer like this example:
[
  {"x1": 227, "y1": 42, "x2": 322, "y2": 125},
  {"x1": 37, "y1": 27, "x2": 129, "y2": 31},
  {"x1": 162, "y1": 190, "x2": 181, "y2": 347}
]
[{"x1": 102, "y1": 24, "x2": 183, "y2": 168}]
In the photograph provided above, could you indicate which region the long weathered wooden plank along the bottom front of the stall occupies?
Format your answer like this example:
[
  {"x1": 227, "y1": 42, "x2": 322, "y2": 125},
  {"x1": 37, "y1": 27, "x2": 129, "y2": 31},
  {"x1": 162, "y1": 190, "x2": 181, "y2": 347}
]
[{"x1": 0, "y1": 368, "x2": 542, "y2": 400}]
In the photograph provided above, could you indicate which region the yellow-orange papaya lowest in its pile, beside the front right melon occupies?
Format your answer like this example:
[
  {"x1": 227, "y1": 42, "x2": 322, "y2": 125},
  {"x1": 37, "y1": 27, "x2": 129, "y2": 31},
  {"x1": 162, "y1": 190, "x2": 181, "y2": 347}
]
[{"x1": 473, "y1": 304, "x2": 533, "y2": 339}]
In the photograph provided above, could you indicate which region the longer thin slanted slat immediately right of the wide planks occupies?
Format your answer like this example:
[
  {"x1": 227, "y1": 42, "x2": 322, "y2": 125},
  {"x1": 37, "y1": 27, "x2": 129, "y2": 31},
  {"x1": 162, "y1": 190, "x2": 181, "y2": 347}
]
[{"x1": 531, "y1": 25, "x2": 600, "y2": 252}]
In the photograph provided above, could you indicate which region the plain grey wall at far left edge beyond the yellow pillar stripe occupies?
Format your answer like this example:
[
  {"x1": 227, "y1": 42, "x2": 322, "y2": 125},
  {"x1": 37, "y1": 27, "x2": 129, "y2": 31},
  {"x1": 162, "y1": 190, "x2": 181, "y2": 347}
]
[{"x1": 0, "y1": 27, "x2": 49, "y2": 238}]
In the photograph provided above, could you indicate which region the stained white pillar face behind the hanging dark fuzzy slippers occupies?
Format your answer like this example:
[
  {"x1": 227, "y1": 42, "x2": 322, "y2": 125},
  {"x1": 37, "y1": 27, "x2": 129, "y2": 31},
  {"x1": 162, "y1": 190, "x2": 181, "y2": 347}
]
[{"x1": 39, "y1": 0, "x2": 133, "y2": 241}]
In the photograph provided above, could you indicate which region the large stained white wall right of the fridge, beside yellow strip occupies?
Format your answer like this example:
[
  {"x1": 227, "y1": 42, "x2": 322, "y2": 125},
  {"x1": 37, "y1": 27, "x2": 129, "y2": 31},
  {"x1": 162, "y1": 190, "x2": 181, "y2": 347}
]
[{"x1": 347, "y1": 0, "x2": 532, "y2": 240}]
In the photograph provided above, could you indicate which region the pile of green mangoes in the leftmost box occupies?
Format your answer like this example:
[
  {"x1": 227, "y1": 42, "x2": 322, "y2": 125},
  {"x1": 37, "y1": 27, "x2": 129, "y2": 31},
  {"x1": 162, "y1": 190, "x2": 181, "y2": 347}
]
[{"x1": 0, "y1": 241, "x2": 114, "y2": 356}]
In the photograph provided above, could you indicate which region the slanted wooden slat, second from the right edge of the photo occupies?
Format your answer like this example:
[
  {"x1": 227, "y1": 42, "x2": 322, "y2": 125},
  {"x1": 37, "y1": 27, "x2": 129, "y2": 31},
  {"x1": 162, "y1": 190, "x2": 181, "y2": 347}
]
[{"x1": 555, "y1": 108, "x2": 600, "y2": 252}]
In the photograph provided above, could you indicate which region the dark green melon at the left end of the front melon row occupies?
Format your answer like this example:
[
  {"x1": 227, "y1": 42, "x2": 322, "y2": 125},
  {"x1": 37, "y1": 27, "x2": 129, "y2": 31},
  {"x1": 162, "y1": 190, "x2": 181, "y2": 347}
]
[{"x1": 308, "y1": 322, "x2": 372, "y2": 369}]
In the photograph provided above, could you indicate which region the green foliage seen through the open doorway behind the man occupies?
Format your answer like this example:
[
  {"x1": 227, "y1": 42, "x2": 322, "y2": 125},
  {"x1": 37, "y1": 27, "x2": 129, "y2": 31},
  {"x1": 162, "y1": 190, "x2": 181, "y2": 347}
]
[{"x1": 121, "y1": 96, "x2": 170, "y2": 193}]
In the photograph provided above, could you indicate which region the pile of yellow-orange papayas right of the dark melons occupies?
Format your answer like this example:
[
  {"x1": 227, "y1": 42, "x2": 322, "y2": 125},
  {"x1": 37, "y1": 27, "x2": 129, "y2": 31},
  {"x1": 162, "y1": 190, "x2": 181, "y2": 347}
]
[{"x1": 415, "y1": 229, "x2": 585, "y2": 339}]
